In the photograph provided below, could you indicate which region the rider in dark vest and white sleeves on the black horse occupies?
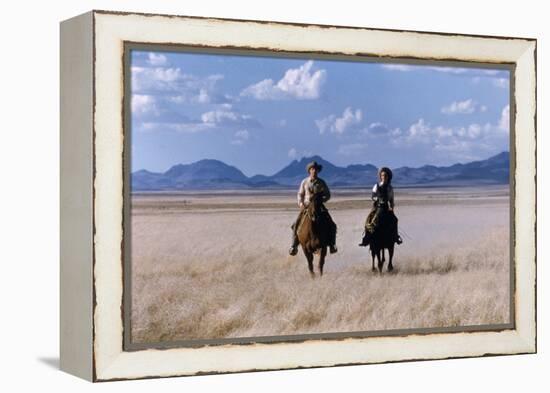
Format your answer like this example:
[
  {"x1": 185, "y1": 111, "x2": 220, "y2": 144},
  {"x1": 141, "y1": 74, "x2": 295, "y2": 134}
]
[{"x1": 359, "y1": 167, "x2": 403, "y2": 247}]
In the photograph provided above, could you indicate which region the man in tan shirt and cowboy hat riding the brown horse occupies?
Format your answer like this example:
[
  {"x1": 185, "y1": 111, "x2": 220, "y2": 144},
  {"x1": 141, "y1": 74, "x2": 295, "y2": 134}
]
[{"x1": 288, "y1": 161, "x2": 338, "y2": 255}]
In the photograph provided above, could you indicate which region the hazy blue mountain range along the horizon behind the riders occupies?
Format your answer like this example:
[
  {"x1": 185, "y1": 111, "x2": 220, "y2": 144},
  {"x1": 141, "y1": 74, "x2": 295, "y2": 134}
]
[{"x1": 131, "y1": 152, "x2": 510, "y2": 191}]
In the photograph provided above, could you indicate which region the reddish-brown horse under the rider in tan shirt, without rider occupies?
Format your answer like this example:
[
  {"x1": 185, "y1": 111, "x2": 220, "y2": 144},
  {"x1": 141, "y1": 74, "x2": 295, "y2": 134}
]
[{"x1": 297, "y1": 195, "x2": 336, "y2": 277}]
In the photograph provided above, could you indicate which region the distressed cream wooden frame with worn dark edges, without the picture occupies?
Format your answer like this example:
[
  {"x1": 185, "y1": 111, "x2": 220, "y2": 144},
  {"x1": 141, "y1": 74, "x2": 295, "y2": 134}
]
[{"x1": 60, "y1": 11, "x2": 536, "y2": 381}]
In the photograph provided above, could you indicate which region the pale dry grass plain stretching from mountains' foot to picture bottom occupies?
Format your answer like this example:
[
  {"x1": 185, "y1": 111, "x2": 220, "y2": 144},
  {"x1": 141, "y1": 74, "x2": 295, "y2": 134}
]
[{"x1": 131, "y1": 186, "x2": 510, "y2": 343}]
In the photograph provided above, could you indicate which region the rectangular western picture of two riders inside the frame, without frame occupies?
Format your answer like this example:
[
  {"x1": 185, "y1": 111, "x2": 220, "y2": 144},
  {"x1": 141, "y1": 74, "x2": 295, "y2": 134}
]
[{"x1": 125, "y1": 47, "x2": 513, "y2": 346}]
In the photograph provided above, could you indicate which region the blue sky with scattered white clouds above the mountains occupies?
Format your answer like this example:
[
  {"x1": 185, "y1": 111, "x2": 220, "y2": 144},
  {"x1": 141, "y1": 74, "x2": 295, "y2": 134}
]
[{"x1": 131, "y1": 50, "x2": 510, "y2": 176}]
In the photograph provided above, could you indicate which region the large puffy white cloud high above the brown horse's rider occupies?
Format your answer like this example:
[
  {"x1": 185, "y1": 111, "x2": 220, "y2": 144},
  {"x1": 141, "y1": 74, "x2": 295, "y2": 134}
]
[{"x1": 241, "y1": 60, "x2": 326, "y2": 100}]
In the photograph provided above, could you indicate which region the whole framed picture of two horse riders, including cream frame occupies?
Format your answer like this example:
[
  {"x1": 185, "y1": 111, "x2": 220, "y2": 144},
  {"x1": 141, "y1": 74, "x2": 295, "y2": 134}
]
[{"x1": 60, "y1": 11, "x2": 536, "y2": 381}]
